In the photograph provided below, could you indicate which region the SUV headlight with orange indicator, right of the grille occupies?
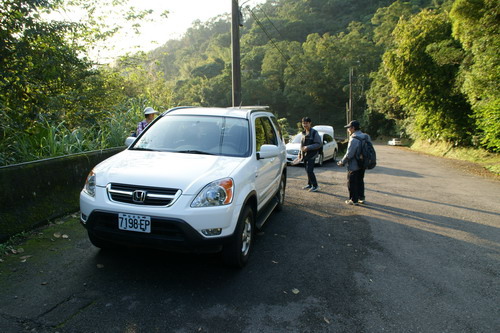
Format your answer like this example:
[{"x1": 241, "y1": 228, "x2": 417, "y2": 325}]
[{"x1": 191, "y1": 178, "x2": 234, "y2": 207}]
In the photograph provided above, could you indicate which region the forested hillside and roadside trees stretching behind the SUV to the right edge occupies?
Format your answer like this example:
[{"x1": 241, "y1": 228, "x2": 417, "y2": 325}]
[{"x1": 146, "y1": 0, "x2": 500, "y2": 151}]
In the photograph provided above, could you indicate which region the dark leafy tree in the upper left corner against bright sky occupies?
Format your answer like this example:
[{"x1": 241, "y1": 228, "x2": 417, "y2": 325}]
[{"x1": 0, "y1": 0, "x2": 87, "y2": 130}]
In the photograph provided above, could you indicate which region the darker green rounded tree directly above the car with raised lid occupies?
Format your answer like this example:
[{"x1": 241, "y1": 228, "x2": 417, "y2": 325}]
[{"x1": 286, "y1": 22, "x2": 381, "y2": 124}]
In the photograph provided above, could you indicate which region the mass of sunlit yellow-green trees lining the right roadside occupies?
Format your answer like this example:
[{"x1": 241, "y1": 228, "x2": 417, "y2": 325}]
[{"x1": 368, "y1": 0, "x2": 500, "y2": 152}]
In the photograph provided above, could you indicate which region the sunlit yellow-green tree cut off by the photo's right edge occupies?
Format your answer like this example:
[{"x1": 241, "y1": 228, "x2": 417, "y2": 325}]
[{"x1": 450, "y1": 0, "x2": 500, "y2": 152}]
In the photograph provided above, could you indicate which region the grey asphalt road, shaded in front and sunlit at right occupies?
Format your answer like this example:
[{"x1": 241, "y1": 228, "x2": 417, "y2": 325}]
[{"x1": 0, "y1": 146, "x2": 500, "y2": 333}]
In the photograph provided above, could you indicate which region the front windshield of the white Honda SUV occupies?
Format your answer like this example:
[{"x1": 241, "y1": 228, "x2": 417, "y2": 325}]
[{"x1": 130, "y1": 114, "x2": 250, "y2": 157}]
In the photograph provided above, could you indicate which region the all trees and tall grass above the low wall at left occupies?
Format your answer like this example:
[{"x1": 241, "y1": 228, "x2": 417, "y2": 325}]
[{"x1": 0, "y1": 0, "x2": 169, "y2": 165}]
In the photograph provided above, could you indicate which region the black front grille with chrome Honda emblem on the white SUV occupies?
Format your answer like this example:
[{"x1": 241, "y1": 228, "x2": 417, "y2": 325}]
[{"x1": 106, "y1": 183, "x2": 182, "y2": 206}]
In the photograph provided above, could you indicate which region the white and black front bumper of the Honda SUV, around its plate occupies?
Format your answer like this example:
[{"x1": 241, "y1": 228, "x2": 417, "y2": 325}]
[{"x1": 80, "y1": 187, "x2": 241, "y2": 252}]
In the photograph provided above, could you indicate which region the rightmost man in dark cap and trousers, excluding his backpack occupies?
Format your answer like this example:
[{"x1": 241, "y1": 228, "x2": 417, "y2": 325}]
[{"x1": 337, "y1": 120, "x2": 371, "y2": 206}]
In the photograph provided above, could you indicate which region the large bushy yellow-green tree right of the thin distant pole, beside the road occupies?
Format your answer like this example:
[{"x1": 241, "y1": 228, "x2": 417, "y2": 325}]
[{"x1": 384, "y1": 10, "x2": 472, "y2": 144}]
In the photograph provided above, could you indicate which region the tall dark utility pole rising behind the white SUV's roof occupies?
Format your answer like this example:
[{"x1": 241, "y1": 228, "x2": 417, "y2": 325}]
[{"x1": 231, "y1": 0, "x2": 241, "y2": 106}]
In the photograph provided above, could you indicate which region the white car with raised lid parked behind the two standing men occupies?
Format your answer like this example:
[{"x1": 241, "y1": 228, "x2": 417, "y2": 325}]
[{"x1": 286, "y1": 125, "x2": 339, "y2": 166}]
